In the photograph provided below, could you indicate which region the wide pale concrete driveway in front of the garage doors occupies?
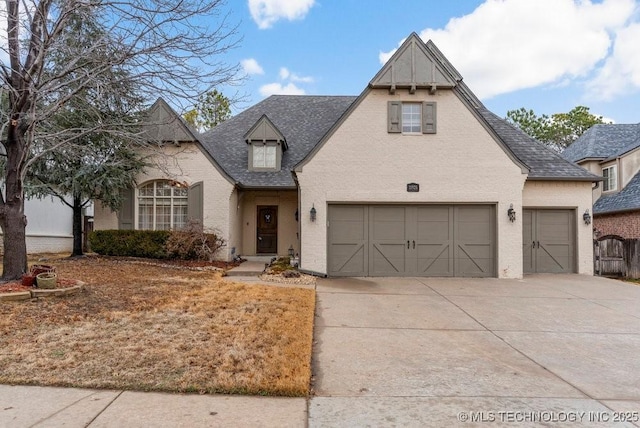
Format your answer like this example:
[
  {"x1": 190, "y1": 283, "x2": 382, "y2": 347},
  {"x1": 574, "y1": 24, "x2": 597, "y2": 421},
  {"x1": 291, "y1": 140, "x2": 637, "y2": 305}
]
[{"x1": 309, "y1": 275, "x2": 640, "y2": 427}]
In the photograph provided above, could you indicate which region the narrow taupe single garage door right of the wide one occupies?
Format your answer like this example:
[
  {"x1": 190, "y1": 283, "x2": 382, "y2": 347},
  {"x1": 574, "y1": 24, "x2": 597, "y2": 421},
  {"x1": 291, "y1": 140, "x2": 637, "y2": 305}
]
[{"x1": 522, "y1": 209, "x2": 576, "y2": 273}]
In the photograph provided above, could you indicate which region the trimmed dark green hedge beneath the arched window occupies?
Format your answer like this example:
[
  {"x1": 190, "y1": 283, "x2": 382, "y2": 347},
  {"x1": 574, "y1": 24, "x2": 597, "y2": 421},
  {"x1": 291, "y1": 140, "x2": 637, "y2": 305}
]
[{"x1": 89, "y1": 230, "x2": 171, "y2": 259}]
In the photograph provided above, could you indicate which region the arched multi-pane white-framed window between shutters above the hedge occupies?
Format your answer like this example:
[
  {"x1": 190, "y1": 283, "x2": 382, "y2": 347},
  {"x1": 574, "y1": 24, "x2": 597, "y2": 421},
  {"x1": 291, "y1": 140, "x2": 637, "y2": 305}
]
[{"x1": 138, "y1": 180, "x2": 188, "y2": 230}]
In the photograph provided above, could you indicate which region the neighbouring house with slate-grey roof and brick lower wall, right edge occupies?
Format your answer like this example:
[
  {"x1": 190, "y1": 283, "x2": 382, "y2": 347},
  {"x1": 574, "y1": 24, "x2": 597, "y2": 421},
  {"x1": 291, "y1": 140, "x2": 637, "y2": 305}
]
[{"x1": 562, "y1": 123, "x2": 640, "y2": 239}]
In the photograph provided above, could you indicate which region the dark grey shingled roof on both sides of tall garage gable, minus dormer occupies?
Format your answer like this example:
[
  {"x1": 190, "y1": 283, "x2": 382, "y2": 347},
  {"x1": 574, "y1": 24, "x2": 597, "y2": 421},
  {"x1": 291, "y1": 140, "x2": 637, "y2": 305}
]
[{"x1": 201, "y1": 93, "x2": 599, "y2": 188}]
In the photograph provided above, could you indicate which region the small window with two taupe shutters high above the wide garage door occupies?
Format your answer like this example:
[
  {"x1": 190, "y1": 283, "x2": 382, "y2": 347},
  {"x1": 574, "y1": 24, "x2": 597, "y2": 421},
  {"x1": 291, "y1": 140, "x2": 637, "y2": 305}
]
[{"x1": 387, "y1": 101, "x2": 437, "y2": 134}]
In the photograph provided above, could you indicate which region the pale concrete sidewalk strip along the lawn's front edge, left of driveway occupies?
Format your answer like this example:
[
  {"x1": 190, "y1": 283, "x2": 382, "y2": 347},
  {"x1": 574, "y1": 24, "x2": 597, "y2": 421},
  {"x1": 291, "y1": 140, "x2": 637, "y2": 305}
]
[{"x1": 0, "y1": 385, "x2": 307, "y2": 428}]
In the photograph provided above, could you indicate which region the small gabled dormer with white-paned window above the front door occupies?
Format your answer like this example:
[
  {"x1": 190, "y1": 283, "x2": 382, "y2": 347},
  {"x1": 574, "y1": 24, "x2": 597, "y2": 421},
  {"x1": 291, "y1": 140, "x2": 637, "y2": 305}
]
[{"x1": 244, "y1": 114, "x2": 287, "y2": 171}]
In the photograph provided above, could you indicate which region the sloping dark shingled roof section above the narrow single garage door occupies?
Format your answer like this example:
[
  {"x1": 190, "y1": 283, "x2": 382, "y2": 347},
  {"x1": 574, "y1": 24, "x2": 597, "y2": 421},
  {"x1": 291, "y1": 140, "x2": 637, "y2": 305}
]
[{"x1": 478, "y1": 106, "x2": 599, "y2": 181}]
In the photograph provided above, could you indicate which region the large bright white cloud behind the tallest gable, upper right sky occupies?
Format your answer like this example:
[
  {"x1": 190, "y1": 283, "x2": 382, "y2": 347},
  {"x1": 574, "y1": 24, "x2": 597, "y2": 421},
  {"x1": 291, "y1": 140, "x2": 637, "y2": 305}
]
[{"x1": 380, "y1": 0, "x2": 640, "y2": 98}]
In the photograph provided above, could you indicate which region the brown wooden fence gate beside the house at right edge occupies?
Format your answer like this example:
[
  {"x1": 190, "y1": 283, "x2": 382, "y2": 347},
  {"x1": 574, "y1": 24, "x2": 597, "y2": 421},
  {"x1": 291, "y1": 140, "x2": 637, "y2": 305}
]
[{"x1": 593, "y1": 235, "x2": 640, "y2": 278}]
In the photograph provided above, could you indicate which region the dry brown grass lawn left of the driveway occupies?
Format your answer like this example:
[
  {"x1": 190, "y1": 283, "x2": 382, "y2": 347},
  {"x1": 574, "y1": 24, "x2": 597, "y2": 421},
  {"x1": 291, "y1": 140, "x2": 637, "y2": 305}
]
[{"x1": 0, "y1": 257, "x2": 315, "y2": 396}]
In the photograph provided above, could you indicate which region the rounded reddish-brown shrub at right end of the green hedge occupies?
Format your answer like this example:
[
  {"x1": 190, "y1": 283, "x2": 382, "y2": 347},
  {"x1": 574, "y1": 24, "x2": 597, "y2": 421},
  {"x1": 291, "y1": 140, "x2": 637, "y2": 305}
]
[{"x1": 166, "y1": 220, "x2": 225, "y2": 261}]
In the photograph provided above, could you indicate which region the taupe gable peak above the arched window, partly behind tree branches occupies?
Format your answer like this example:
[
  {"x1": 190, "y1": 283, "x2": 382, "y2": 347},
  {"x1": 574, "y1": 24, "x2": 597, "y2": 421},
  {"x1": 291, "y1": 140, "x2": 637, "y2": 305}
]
[{"x1": 144, "y1": 98, "x2": 198, "y2": 143}]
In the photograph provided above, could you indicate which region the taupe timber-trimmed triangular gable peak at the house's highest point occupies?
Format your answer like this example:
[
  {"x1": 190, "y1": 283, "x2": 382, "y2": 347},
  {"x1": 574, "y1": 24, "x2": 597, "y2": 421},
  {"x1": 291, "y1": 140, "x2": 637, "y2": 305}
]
[{"x1": 369, "y1": 33, "x2": 461, "y2": 93}]
